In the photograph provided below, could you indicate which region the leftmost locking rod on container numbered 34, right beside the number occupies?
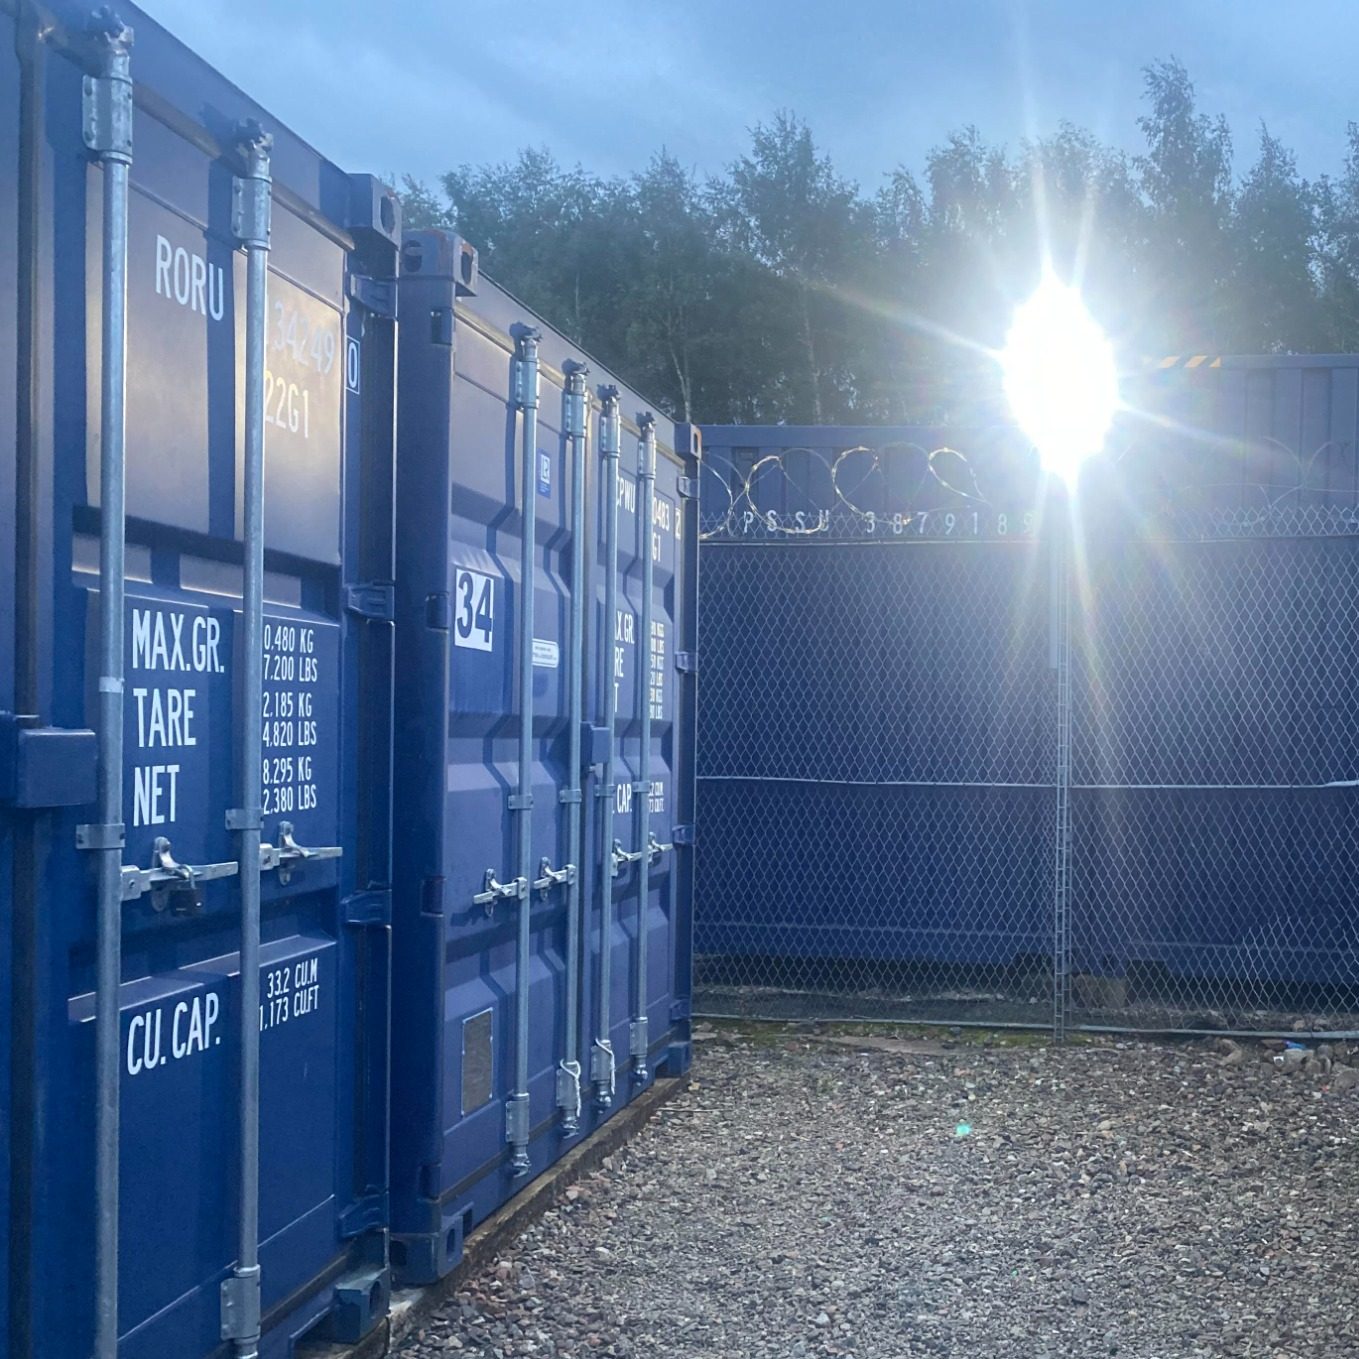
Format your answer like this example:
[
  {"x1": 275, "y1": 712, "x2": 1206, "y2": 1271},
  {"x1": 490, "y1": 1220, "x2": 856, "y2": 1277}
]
[{"x1": 506, "y1": 329, "x2": 540, "y2": 1176}]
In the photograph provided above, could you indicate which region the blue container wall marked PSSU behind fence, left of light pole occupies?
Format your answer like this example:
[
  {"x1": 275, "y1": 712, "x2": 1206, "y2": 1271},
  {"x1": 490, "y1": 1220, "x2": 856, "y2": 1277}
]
[{"x1": 696, "y1": 427, "x2": 1055, "y2": 981}]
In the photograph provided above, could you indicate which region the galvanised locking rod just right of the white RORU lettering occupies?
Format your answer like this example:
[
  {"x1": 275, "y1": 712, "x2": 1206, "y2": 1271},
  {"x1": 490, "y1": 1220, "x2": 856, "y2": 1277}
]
[{"x1": 222, "y1": 122, "x2": 273, "y2": 1359}]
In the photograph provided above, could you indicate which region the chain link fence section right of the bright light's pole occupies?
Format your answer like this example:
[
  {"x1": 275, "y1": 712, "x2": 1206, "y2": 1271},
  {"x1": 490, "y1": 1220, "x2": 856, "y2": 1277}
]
[{"x1": 1071, "y1": 504, "x2": 1359, "y2": 1030}]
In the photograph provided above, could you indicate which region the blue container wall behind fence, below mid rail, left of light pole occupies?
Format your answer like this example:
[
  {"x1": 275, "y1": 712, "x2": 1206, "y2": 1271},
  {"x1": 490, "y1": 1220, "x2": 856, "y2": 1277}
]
[{"x1": 694, "y1": 779, "x2": 1052, "y2": 981}]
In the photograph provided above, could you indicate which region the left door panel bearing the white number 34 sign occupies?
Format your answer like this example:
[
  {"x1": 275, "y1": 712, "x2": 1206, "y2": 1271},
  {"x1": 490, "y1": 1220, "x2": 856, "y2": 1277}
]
[{"x1": 443, "y1": 326, "x2": 571, "y2": 1203}]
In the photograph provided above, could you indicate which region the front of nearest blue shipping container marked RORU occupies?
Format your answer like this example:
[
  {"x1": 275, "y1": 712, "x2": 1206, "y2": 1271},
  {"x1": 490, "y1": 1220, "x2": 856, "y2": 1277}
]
[{"x1": 0, "y1": 4, "x2": 398, "y2": 1359}]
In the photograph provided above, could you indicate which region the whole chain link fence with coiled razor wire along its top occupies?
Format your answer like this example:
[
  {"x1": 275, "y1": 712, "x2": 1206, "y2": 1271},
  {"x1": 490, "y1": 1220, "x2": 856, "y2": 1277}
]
[{"x1": 696, "y1": 431, "x2": 1359, "y2": 1036}]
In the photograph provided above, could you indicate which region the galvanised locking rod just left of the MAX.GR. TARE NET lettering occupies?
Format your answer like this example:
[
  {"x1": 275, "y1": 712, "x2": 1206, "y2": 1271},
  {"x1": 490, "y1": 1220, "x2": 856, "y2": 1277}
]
[{"x1": 84, "y1": 10, "x2": 132, "y2": 1359}]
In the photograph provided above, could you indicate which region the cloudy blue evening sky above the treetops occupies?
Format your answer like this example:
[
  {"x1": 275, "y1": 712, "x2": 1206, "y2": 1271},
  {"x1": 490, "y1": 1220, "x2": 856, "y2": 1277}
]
[{"x1": 141, "y1": 0, "x2": 1359, "y2": 193}]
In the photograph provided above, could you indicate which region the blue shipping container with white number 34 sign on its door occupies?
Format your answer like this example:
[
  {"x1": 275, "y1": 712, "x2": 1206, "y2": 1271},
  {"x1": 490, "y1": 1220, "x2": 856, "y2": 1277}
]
[{"x1": 391, "y1": 232, "x2": 699, "y2": 1280}]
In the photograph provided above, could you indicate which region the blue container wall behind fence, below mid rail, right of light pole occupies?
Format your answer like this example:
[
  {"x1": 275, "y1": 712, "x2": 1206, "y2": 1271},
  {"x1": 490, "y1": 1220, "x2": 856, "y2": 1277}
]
[{"x1": 1072, "y1": 788, "x2": 1359, "y2": 989}]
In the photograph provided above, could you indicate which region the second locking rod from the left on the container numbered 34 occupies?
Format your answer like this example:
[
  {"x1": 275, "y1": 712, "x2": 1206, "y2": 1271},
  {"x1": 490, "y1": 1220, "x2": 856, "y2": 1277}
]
[{"x1": 557, "y1": 363, "x2": 588, "y2": 1137}]
